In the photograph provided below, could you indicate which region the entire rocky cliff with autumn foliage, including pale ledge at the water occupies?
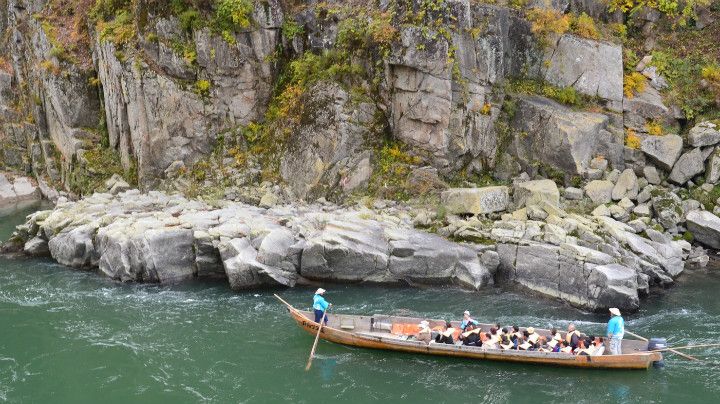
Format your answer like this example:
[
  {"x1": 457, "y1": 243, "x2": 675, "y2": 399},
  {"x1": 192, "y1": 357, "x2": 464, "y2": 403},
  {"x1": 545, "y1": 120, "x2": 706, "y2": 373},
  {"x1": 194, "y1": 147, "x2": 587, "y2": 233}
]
[{"x1": 0, "y1": 0, "x2": 720, "y2": 308}]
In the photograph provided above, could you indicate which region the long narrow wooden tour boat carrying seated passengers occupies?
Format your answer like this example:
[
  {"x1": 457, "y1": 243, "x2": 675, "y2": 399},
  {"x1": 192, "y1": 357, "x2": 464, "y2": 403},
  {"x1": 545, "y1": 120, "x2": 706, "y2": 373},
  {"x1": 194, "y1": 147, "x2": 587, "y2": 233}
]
[{"x1": 278, "y1": 297, "x2": 663, "y2": 369}]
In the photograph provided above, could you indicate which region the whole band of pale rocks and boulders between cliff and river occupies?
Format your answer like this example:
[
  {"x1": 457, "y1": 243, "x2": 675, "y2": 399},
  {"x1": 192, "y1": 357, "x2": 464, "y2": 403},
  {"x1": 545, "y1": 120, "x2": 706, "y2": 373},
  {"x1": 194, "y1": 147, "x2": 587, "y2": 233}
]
[{"x1": 5, "y1": 160, "x2": 720, "y2": 310}]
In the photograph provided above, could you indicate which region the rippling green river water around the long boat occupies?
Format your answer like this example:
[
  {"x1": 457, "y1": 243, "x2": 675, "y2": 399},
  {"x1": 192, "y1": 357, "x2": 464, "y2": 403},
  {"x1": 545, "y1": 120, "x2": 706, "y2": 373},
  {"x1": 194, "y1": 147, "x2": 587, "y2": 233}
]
[{"x1": 0, "y1": 207, "x2": 720, "y2": 404}]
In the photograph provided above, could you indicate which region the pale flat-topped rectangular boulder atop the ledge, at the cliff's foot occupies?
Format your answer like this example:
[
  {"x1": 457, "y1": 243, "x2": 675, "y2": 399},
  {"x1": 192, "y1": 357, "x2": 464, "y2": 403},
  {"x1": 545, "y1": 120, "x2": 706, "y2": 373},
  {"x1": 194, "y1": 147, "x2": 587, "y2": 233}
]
[{"x1": 440, "y1": 186, "x2": 510, "y2": 215}]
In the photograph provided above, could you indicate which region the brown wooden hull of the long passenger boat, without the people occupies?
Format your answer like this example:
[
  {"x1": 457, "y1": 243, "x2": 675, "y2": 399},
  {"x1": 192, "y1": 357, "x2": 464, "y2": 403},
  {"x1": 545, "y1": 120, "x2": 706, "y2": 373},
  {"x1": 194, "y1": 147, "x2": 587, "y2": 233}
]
[{"x1": 285, "y1": 303, "x2": 662, "y2": 369}]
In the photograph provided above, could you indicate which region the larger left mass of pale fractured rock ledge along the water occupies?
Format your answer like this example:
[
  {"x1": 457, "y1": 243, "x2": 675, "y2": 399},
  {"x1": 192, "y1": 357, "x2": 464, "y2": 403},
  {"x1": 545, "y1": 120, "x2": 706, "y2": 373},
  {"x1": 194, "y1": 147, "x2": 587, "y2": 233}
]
[{"x1": 11, "y1": 190, "x2": 495, "y2": 290}]
